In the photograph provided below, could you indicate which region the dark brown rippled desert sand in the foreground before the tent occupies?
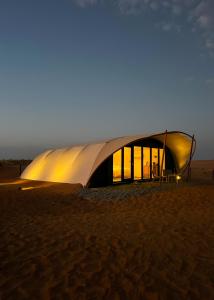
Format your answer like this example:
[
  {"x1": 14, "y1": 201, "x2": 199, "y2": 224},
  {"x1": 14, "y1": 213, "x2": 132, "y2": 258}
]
[{"x1": 0, "y1": 162, "x2": 214, "y2": 300}]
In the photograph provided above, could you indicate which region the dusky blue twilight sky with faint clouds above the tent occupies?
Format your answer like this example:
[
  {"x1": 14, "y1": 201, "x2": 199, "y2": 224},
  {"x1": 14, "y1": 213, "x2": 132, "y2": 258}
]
[{"x1": 0, "y1": 0, "x2": 214, "y2": 159}]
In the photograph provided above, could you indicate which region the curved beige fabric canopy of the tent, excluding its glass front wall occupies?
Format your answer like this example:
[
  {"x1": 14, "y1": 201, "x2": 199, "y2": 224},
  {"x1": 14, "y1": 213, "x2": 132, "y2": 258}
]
[{"x1": 21, "y1": 131, "x2": 195, "y2": 186}]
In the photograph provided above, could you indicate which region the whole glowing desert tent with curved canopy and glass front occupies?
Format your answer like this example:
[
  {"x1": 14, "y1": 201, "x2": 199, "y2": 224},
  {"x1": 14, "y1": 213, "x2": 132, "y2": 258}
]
[{"x1": 21, "y1": 131, "x2": 195, "y2": 187}]
